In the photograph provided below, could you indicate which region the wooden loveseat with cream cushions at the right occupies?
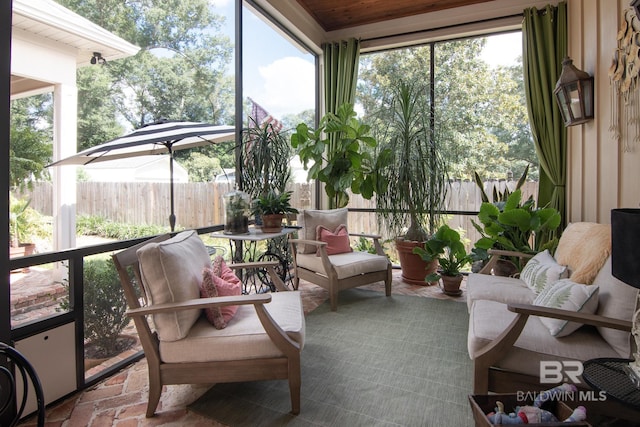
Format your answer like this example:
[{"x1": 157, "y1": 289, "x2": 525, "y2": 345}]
[{"x1": 467, "y1": 223, "x2": 638, "y2": 394}]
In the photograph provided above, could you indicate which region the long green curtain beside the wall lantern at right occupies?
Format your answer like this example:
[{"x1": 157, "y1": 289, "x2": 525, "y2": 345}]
[{"x1": 522, "y1": 2, "x2": 567, "y2": 234}]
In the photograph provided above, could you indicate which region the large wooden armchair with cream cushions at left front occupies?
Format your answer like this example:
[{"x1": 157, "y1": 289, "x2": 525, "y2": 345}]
[{"x1": 113, "y1": 231, "x2": 305, "y2": 417}]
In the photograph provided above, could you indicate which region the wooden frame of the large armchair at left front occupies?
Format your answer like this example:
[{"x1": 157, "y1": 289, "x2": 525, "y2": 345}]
[{"x1": 112, "y1": 235, "x2": 301, "y2": 417}]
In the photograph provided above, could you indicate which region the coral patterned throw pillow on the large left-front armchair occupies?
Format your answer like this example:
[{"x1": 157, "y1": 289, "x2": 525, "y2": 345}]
[{"x1": 200, "y1": 256, "x2": 242, "y2": 329}]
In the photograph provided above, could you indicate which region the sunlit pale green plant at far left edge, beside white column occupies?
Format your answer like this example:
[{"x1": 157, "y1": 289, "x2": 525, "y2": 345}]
[{"x1": 9, "y1": 193, "x2": 51, "y2": 246}]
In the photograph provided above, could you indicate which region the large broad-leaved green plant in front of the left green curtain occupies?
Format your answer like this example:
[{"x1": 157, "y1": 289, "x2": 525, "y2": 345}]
[{"x1": 291, "y1": 103, "x2": 386, "y2": 207}]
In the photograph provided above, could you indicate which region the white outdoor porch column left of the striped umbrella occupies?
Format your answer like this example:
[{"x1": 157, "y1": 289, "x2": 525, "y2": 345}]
[{"x1": 52, "y1": 83, "x2": 78, "y2": 251}]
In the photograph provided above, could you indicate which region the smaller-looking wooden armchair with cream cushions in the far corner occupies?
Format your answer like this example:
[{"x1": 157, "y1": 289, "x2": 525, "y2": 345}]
[{"x1": 289, "y1": 208, "x2": 392, "y2": 311}]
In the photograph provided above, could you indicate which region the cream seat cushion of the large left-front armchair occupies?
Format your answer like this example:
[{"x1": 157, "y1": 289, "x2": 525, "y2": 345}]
[{"x1": 160, "y1": 291, "x2": 305, "y2": 363}]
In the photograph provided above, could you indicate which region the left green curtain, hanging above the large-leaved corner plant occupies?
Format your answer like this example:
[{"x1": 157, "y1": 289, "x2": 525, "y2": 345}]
[{"x1": 322, "y1": 38, "x2": 360, "y2": 113}]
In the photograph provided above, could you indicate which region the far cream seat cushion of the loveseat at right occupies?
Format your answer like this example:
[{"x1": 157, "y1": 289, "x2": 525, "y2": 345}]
[{"x1": 466, "y1": 273, "x2": 536, "y2": 309}]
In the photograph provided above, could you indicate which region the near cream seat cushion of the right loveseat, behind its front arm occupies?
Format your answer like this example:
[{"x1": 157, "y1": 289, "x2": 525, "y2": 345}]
[{"x1": 467, "y1": 300, "x2": 619, "y2": 376}]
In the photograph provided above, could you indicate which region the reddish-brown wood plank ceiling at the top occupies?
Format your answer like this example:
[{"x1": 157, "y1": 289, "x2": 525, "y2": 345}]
[{"x1": 297, "y1": 0, "x2": 492, "y2": 31}]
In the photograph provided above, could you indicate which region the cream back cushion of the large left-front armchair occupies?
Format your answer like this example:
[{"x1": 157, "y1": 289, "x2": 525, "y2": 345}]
[{"x1": 136, "y1": 230, "x2": 211, "y2": 341}]
